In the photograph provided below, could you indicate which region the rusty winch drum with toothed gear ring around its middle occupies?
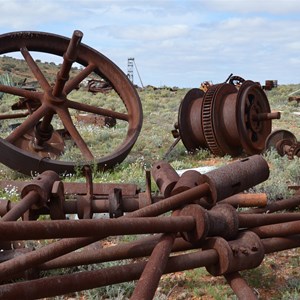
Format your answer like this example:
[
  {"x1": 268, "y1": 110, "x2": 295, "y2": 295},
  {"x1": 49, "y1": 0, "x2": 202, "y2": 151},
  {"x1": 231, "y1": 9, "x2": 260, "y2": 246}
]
[{"x1": 178, "y1": 80, "x2": 280, "y2": 156}]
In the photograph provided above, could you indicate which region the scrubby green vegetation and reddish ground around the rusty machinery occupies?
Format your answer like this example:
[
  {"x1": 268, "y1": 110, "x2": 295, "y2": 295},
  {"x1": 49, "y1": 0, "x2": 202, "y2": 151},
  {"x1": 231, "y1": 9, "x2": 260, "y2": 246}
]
[{"x1": 0, "y1": 57, "x2": 300, "y2": 299}]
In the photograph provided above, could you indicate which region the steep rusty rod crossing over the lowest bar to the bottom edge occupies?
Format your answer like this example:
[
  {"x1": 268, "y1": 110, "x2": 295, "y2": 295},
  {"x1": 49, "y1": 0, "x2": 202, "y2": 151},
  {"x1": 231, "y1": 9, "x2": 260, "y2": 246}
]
[{"x1": 130, "y1": 234, "x2": 175, "y2": 300}]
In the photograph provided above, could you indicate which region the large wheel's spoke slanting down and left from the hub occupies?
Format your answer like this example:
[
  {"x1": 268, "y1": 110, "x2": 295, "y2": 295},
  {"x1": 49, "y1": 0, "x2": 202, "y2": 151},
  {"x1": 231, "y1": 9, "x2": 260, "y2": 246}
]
[{"x1": 6, "y1": 105, "x2": 49, "y2": 144}]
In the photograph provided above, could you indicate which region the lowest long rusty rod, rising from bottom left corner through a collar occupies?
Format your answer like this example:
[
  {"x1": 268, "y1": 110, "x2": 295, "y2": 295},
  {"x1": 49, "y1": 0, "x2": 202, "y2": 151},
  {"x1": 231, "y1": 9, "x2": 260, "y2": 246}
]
[{"x1": 0, "y1": 235, "x2": 300, "y2": 300}]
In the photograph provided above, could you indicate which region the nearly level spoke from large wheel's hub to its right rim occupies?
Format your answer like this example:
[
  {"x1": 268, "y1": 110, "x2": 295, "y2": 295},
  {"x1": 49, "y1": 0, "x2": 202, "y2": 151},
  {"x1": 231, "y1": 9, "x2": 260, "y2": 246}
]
[{"x1": 67, "y1": 100, "x2": 129, "y2": 122}]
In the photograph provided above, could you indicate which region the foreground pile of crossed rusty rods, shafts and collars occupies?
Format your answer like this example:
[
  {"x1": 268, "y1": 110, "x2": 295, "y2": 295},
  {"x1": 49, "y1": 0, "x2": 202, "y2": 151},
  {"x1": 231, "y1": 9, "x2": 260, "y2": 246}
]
[{"x1": 0, "y1": 155, "x2": 300, "y2": 299}]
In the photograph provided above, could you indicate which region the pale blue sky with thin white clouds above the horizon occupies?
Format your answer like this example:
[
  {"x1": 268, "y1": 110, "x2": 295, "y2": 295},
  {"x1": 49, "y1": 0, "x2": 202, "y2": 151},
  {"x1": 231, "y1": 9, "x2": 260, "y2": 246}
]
[{"x1": 0, "y1": 0, "x2": 300, "y2": 88}]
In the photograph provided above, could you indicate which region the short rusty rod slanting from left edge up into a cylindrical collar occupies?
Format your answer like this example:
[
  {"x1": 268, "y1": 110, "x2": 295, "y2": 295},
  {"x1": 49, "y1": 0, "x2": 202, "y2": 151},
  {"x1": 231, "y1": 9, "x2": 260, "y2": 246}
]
[{"x1": 0, "y1": 191, "x2": 40, "y2": 221}]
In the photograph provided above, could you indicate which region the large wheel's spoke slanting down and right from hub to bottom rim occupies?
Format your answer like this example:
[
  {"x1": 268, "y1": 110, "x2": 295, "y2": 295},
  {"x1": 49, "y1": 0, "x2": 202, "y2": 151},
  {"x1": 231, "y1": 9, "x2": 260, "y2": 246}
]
[{"x1": 56, "y1": 109, "x2": 94, "y2": 161}]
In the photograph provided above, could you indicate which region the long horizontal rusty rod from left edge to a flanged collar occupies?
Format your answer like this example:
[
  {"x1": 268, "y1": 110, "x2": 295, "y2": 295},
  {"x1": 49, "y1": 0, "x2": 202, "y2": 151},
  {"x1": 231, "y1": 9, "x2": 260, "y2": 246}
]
[{"x1": 0, "y1": 216, "x2": 196, "y2": 240}]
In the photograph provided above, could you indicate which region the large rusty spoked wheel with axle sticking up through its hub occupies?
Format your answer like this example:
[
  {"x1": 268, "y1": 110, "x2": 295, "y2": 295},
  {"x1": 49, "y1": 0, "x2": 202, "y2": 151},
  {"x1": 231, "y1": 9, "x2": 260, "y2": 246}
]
[{"x1": 0, "y1": 31, "x2": 143, "y2": 175}]
